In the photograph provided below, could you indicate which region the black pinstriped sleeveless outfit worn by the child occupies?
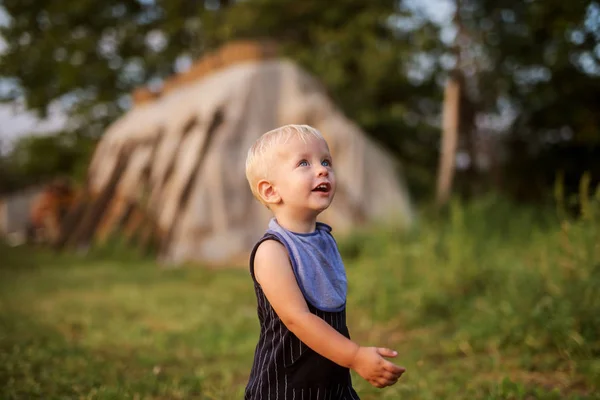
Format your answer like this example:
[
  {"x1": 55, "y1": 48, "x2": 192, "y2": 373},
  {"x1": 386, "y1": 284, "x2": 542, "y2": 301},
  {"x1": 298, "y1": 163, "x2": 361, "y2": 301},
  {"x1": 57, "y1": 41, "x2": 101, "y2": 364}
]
[{"x1": 244, "y1": 234, "x2": 359, "y2": 400}]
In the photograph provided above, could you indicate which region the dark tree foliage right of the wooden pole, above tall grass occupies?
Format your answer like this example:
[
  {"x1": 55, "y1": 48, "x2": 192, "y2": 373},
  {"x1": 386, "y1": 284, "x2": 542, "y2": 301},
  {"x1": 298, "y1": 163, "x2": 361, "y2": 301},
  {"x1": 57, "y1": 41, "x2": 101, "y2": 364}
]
[{"x1": 459, "y1": 0, "x2": 600, "y2": 199}]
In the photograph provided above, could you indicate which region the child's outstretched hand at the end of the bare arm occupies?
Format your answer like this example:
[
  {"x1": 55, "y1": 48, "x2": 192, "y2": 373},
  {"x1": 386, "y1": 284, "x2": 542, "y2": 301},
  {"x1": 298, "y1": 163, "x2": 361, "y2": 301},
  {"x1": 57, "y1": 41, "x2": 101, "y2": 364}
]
[{"x1": 350, "y1": 347, "x2": 406, "y2": 388}]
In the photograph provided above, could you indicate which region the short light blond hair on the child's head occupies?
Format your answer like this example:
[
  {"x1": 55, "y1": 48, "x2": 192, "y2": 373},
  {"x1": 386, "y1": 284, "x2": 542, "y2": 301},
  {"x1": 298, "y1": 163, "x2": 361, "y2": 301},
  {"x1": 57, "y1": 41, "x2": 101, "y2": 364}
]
[{"x1": 246, "y1": 124, "x2": 325, "y2": 205}]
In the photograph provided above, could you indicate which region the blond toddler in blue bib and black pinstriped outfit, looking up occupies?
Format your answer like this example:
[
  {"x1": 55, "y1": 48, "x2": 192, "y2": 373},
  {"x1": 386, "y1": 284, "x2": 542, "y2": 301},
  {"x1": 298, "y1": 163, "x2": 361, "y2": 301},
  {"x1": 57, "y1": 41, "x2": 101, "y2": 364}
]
[{"x1": 245, "y1": 125, "x2": 405, "y2": 400}]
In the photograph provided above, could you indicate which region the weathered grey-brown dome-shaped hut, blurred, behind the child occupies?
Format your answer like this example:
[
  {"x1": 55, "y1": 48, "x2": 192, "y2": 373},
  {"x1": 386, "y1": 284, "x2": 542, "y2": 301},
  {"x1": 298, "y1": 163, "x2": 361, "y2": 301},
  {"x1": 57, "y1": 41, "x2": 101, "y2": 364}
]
[{"x1": 77, "y1": 54, "x2": 412, "y2": 265}]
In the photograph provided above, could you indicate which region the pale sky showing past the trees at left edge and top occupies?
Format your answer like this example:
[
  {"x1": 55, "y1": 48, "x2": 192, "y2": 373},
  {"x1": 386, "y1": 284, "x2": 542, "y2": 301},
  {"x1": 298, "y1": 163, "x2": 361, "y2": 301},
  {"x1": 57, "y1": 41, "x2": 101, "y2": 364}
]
[{"x1": 0, "y1": 0, "x2": 454, "y2": 152}]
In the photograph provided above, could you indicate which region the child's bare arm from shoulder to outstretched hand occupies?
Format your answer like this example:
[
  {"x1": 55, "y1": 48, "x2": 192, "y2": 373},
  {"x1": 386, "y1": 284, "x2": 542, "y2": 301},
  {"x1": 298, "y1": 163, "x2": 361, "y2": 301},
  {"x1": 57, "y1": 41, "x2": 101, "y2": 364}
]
[{"x1": 254, "y1": 240, "x2": 404, "y2": 387}]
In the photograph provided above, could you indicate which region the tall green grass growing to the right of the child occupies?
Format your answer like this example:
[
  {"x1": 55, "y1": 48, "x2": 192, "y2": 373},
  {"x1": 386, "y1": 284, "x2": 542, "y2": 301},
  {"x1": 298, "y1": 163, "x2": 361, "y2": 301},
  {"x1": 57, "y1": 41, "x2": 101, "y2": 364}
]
[{"x1": 342, "y1": 192, "x2": 600, "y2": 348}]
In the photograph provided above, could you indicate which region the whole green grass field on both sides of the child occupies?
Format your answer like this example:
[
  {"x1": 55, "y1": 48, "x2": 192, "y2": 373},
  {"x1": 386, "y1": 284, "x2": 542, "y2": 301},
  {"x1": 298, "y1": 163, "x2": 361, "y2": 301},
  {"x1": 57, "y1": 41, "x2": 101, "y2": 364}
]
[{"x1": 0, "y1": 198, "x2": 600, "y2": 400}]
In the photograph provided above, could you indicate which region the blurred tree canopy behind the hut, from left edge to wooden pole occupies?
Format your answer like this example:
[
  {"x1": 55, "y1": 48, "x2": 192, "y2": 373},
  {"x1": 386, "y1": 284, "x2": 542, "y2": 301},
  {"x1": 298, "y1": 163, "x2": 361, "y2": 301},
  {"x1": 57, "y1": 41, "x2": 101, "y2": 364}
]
[{"x1": 0, "y1": 0, "x2": 442, "y2": 200}]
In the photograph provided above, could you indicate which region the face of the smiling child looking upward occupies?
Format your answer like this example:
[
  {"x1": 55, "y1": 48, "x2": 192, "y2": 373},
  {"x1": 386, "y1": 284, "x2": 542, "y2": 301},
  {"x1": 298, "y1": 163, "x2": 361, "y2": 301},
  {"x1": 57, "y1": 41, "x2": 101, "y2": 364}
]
[{"x1": 272, "y1": 137, "x2": 336, "y2": 215}]
